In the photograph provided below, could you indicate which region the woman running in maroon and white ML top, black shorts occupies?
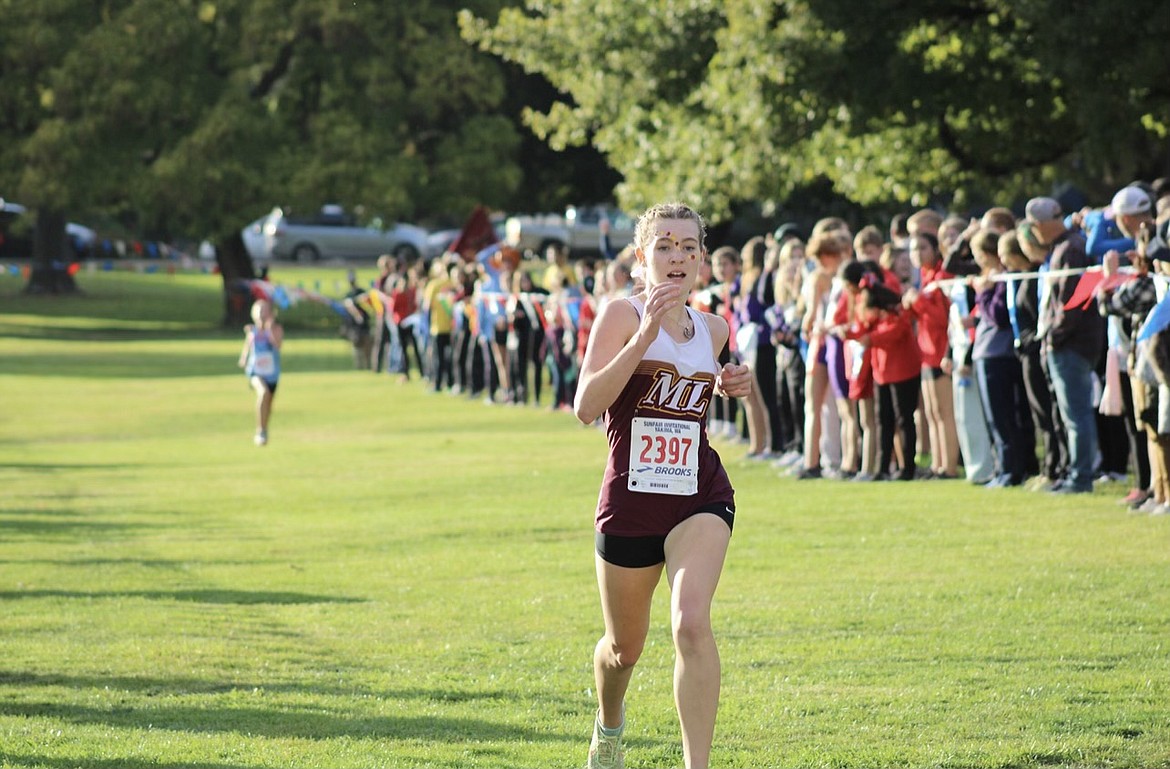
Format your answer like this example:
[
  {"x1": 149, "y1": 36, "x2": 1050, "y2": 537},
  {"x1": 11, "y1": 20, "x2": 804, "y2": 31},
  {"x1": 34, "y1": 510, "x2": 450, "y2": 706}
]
[{"x1": 574, "y1": 204, "x2": 751, "y2": 768}]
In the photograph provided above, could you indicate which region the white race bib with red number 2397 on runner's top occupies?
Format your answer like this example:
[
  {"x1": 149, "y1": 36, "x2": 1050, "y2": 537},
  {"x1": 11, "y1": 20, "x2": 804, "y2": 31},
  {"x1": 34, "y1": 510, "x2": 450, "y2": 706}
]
[{"x1": 627, "y1": 417, "x2": 698, "y2": 496}]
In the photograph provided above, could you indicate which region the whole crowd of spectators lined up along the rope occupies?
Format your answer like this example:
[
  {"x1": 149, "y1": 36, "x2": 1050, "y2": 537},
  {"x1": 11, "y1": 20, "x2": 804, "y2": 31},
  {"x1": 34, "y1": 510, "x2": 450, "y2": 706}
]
[{"x1": 346, "y1": 180, "x2": 1170, "y2": 514}]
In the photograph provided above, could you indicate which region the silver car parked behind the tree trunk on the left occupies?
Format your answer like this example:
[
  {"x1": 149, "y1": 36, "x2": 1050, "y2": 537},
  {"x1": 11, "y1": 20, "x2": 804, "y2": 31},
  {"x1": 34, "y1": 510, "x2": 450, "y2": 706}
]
[{"x1": 258, "y1": 205, "x2": 427, "y2": 262}]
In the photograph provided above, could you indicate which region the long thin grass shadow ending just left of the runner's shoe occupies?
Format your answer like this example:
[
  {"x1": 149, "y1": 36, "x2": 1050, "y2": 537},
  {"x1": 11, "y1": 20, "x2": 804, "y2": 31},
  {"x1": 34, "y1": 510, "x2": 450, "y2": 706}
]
[{"x1": 0, "y1": 702, "x2": 581, "y2": 744}]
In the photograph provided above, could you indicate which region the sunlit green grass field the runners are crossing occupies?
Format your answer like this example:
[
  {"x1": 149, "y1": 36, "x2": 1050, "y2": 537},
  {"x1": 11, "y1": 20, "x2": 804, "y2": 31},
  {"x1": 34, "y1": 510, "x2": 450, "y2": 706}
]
[{"x1": 0, "y1": 266, "x2": 1170, "y2": 769}]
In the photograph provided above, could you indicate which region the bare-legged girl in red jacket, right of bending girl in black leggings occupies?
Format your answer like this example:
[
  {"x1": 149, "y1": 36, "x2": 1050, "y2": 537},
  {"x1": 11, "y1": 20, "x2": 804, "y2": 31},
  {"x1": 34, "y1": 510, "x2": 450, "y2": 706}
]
[{"x1": 902, "y1": 233, "x2": 958, "y2": 478}]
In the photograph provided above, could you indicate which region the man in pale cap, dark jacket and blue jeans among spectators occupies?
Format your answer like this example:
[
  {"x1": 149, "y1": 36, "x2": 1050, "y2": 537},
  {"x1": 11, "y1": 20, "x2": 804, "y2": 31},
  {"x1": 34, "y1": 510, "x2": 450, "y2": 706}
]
[{"x1": 1025, "y1": 198, "x2": 1104, "y2": 494}]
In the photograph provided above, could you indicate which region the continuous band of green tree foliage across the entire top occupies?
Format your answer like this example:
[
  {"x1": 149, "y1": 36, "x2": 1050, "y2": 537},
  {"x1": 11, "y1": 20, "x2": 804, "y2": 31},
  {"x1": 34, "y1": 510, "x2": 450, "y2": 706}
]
[{"x1": 0, "y1": 0, "x2": 1170, "y2": 262}]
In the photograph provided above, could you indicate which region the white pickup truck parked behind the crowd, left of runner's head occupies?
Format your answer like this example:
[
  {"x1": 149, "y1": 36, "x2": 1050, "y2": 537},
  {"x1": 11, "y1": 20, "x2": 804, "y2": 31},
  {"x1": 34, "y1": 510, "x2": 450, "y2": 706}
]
[{"x1": 504, "y1": 206, "x2": 634, "y2": 256}]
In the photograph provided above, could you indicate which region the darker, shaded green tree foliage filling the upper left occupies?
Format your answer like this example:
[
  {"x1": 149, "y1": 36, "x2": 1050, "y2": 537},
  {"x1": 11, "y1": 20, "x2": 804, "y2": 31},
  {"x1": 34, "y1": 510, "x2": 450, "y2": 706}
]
[{"x1": 0, "y1": 0, "x2": 521, "y2": 311}]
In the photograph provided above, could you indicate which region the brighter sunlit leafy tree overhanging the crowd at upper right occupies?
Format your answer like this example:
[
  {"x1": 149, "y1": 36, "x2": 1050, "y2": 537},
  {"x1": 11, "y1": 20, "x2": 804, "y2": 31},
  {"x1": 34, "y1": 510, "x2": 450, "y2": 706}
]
[{"x1": 460, "y1": 0, "x2": 1170, "y2": 218}]
